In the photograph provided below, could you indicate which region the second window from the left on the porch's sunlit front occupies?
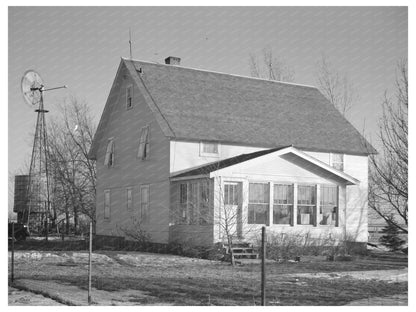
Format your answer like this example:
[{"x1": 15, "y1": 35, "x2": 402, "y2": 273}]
[{"x1": 273, "y1": 184, "x2": 293, "y2": 224}]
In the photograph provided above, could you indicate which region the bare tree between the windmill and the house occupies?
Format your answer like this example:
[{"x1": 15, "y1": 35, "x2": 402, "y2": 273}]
[{"x1": 48, "y1": 97, "x2": 96, "y2": 233}]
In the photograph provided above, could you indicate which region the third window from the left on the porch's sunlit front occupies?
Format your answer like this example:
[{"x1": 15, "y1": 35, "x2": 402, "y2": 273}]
[{"x1": 297, "y1": 185, "x2": 316, "y2": 224}]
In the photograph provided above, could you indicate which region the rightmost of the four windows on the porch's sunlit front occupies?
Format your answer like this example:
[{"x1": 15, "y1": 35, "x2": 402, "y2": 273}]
[{"x1": 318, "y1": 185, "x2": 338, "y2": 226}]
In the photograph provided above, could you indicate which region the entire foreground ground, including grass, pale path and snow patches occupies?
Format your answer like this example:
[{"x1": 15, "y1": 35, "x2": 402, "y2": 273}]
[{"x1": 9, "y1": 251, "x2": 408, "y2": 306}]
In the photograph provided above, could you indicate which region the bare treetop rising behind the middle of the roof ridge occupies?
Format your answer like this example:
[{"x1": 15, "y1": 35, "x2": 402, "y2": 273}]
[{"x1": 249, "y1": 47, "x2": 295, "y2": 82}]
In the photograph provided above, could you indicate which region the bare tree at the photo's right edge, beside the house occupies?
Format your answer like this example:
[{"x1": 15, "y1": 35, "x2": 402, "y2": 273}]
[{"x1": 369, "y1": 59, "x2": 408, "y2": 233}]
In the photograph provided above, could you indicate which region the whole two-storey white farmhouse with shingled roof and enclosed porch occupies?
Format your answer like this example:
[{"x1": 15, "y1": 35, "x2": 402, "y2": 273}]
[{"x1": 90, "y1": 57, "x2": 375, "y2": 245}]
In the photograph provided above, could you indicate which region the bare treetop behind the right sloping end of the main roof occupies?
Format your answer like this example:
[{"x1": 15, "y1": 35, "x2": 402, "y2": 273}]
[{"x1": 316, "y1": 54, "x2": 358, "y2": 117}]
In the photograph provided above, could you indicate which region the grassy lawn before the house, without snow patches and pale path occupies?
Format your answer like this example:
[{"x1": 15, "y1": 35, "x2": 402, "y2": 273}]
[{"x1": 8, "y1": 252, "x2": 407, "y2": 305}]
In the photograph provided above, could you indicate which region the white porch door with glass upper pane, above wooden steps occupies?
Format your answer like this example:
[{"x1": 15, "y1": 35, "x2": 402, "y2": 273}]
[{"x1": 221, "y1": 182, "x2": 243, "y2": 239}]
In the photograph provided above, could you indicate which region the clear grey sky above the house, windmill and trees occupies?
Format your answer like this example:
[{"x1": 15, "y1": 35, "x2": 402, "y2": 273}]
[{"x1": 8, "y1": 7, "x2": 408, "y2": 212}]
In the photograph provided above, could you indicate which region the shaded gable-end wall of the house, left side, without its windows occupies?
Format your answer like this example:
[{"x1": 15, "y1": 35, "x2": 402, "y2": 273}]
[{"x1": 97, "y1": 65, "x2": 169, "y2": 243}]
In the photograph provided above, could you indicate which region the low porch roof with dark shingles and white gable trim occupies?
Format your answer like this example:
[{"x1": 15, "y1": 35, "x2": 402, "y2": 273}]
[{"x1": 171, "y1": 146, "x2": 360, "y2": 184}]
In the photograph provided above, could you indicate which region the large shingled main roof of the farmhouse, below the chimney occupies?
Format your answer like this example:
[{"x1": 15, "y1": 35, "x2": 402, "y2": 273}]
[{"x1": 90, "y1": 59, "x2": 376, "y2": 155}]
